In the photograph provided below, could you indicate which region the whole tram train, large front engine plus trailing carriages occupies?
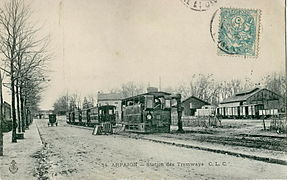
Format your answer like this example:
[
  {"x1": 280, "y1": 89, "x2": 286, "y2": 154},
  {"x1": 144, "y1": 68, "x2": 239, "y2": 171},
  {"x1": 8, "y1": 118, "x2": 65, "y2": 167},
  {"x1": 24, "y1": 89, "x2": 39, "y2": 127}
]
[{"x1": 66, "y1": 92, "x2": 181, "y2": 133}]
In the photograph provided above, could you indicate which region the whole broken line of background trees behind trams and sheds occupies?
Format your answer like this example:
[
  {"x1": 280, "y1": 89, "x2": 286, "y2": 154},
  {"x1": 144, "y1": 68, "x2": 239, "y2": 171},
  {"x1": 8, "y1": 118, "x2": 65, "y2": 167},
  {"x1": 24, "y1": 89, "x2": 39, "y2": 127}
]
[{"x1": 51, "y1": 73, "x2": 286, "y2": 114}]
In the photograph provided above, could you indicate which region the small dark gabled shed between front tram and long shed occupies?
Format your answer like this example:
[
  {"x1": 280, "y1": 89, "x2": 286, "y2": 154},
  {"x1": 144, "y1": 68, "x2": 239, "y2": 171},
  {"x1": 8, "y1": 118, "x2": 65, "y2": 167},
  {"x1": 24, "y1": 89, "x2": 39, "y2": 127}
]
[{"x1": 181, "y1": 96, "x2": 210, "y2": 116}]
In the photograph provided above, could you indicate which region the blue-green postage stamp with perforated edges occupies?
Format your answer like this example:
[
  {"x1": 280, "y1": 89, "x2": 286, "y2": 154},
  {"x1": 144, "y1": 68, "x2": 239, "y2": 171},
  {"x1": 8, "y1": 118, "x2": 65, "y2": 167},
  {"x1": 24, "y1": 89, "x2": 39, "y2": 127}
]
[{"x1": 218, "y1": 8, "x2": 261, "y2": 57}]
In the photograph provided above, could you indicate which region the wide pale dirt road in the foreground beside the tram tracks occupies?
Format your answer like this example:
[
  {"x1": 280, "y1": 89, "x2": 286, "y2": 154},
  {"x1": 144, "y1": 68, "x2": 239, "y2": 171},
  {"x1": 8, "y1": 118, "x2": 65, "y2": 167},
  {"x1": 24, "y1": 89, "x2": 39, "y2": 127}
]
[{"x1": 33, "y1": 120, "x2": 287, "y2": 180}]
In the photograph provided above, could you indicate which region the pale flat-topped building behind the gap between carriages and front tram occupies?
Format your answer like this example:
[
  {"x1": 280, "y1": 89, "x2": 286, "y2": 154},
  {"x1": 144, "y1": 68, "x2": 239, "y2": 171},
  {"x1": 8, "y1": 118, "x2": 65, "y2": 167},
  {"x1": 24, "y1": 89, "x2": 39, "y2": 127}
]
[{"x1": 97, "y1": 92, "x2": 123, "y2": 123}]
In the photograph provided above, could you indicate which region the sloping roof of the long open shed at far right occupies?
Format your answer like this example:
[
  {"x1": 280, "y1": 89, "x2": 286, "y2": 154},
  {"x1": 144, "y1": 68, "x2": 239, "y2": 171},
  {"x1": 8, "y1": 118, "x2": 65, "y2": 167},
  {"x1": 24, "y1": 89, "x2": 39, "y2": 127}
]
[{"x1": 220, "y1": 88, "x2": 263, "y2": 104}]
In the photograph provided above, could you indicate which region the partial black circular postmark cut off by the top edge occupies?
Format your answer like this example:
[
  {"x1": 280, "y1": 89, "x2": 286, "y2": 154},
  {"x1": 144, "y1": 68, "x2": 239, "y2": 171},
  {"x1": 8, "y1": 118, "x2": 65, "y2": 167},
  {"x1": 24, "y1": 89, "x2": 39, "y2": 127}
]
[{"x1": 180, "y1": 0, "x2": 217, "y2": 11}]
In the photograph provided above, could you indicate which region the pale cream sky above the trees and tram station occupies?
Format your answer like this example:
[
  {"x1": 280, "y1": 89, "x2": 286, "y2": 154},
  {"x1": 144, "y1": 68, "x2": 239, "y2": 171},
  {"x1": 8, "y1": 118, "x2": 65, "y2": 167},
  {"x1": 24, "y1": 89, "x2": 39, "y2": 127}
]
[{"x1": 0, "y1": 0, "x2": 285, "y2": 109}]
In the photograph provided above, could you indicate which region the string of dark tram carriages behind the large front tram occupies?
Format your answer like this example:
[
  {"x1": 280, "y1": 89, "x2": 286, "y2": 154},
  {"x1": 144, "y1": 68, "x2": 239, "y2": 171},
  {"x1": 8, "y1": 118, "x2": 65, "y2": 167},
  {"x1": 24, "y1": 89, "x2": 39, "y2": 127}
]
[{"x1": 66, "y1": 105, "x2": 116, "y2": 127}]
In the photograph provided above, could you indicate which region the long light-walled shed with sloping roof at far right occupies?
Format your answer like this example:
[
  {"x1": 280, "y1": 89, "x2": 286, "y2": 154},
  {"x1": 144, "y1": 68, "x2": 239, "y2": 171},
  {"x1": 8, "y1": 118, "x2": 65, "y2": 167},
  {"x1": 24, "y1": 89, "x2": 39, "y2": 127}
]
[{"x1": 220, "y1": 88, "x2": 283, "y2": 118}]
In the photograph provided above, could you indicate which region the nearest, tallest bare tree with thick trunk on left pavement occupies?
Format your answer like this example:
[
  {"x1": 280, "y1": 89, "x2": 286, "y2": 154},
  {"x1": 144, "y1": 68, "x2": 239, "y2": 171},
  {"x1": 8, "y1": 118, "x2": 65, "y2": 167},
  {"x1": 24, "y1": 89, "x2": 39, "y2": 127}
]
[{"x1": 0, "y1": 0, "x2": 31, "y2": 142}]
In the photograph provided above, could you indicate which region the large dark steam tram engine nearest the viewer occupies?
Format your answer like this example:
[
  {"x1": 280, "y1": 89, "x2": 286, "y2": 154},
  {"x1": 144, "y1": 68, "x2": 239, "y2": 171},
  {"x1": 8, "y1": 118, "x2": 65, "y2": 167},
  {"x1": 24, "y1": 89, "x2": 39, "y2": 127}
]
[{"x1": 122, "y1": 91, "x2": 180, "y2": 133}]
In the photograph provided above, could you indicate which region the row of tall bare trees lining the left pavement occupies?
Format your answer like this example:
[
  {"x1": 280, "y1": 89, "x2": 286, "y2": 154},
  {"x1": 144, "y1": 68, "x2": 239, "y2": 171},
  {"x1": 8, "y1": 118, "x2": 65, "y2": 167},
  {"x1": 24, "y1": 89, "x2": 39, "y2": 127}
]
[{"x1": 0, "y1": 0, "x2": 49, "y2": 155}]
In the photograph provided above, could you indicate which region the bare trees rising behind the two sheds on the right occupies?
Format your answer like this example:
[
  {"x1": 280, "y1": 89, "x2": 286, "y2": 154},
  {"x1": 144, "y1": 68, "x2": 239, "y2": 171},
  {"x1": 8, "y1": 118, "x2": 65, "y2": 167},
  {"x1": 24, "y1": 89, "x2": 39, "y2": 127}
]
[{"x1": 165, "y1": 73, "x2": 286, "y2": 105}]
